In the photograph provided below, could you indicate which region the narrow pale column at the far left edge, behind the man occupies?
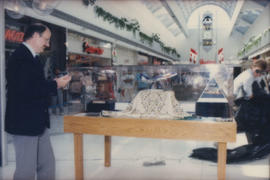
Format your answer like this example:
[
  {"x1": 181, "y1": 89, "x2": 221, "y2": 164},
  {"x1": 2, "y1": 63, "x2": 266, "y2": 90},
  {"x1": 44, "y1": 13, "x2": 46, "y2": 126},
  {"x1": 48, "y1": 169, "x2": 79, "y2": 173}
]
[{"x1": 0, "y1": 0, "x2": 7, "y2": 166}]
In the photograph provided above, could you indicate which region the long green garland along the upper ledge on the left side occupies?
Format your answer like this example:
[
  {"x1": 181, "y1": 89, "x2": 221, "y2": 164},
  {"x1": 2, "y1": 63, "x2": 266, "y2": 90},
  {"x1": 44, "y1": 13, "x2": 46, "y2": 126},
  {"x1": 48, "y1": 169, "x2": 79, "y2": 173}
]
[{"x1": 95, "y1": 6, "x2": 181, "y2": 58}]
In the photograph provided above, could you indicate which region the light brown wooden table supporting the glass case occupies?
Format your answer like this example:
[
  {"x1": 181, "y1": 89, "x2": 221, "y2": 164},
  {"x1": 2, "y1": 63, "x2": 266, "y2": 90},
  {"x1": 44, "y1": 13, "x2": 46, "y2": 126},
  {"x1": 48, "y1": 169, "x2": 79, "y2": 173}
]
[{"x1": 64, "y1": 115, "x2": 236, "y2": 180}]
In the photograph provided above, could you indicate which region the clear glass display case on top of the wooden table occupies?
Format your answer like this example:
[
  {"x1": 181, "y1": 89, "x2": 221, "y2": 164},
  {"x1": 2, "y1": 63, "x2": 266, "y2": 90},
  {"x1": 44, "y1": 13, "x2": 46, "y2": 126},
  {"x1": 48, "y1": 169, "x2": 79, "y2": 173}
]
[{"x1": 63, "y1": 64, "x2": 233, "y2": 121}]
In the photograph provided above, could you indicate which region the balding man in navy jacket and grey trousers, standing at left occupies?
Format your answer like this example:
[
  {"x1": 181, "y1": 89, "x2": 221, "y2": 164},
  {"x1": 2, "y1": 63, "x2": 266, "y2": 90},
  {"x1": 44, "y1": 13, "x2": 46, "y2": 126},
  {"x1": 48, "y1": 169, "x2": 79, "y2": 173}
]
[{"x1": 5, "y1": 24, "x2": 71, "y2": 180}]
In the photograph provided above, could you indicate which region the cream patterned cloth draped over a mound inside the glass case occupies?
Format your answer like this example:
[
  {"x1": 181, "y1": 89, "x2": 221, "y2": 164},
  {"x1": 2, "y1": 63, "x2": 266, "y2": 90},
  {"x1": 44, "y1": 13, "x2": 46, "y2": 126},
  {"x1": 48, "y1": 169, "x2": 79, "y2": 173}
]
[{"x1": 102, "y1": 89, "x2": 191, "y2": 119}]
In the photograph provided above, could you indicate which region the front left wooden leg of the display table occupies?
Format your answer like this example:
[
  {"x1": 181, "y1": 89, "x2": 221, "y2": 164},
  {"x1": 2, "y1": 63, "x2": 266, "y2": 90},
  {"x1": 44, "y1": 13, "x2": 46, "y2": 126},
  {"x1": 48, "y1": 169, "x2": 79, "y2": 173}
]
[{"x1": 74, "y1": 133, "x2": 83, "y2": 180}]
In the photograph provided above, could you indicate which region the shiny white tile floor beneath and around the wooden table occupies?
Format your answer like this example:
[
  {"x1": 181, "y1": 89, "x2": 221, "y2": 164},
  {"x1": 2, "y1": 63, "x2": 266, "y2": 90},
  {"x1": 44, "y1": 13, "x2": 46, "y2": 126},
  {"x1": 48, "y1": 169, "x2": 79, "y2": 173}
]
[{"x1": 0, "y1": 102, "x2": 269, "y2": 180}]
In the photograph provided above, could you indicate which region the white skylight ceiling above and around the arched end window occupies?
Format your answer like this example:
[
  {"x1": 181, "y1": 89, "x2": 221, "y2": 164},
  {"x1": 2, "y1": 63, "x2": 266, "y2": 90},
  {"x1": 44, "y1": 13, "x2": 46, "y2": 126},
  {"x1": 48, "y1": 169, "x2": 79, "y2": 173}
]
[{"x1": 97, "y1": 0, "x2": 270, "y2": 39}]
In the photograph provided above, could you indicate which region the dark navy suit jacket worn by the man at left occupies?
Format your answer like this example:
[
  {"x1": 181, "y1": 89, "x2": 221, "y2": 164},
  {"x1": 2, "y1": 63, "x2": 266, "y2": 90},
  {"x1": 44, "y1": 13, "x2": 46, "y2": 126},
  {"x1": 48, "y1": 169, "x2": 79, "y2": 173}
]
[{"x1": 5, "y1": 44, "x2": 57, "y2": 136}]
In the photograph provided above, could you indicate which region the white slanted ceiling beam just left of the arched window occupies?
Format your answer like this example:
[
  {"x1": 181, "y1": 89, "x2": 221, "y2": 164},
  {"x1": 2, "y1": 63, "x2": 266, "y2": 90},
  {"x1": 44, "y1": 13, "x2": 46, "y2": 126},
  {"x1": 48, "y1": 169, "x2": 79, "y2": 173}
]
[{"x1": 160, "y1": 0, "x2": 188, "y2": 38}]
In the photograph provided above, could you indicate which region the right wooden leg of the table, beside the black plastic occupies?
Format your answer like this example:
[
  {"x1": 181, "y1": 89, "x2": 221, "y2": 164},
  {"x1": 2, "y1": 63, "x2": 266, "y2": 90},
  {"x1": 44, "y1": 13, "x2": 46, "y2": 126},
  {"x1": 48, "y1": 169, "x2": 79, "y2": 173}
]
[{"x1": 217, "y1": 142, "x2": 227, "y2": 180}]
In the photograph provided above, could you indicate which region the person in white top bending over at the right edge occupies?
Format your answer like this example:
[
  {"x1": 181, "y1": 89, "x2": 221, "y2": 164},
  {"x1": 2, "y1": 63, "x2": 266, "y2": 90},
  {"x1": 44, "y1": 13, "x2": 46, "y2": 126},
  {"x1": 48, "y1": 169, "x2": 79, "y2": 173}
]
[{"x1": 234, "y1": 60, "x2": 269, "y2": 143}]
